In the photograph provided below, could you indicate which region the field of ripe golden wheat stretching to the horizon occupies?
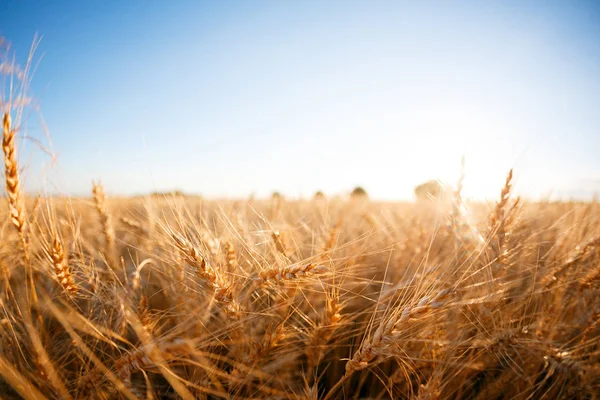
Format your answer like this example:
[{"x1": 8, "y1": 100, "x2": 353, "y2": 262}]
[{"x1": 0, "y1": 108, "x2": 600, "y2": 399}]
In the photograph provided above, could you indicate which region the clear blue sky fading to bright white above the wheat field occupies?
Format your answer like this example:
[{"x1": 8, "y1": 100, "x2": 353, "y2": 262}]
[{"x1": 0, "y1": 0, "x2": 600, "y2": 199}]
